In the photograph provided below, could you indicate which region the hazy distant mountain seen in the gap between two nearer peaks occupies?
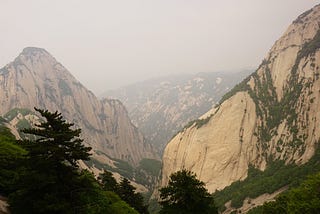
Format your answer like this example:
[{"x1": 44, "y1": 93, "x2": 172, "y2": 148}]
[{"x1": 103, "y1": 70, "x2": 252, "y2": 151}]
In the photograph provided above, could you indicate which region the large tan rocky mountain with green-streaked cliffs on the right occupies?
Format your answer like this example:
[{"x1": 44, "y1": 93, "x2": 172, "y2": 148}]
[{"x1": 160, "y1": 3, "x2": 320, "y2": 209}]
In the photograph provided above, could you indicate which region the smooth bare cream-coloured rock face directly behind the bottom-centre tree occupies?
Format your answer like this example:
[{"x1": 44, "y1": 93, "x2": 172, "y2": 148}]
[{"x1": 162, "y1": 92, "x2": 257, "y2": 190}]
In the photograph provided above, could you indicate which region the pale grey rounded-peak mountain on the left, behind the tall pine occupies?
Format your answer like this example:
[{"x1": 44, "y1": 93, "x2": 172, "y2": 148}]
[{"x1": 0, "y1": 47, "x2": 157, "y2": 165}]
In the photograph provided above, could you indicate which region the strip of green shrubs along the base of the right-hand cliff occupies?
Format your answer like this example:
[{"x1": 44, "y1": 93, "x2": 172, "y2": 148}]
[{"x1": 213, "y1": 146, "x2": 320, "y2": 210}]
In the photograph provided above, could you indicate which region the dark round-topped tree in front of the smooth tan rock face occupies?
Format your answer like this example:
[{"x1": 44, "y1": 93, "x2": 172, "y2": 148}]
[{"x1": 159, "y1": 169, "x2": 218, "y2": 214}]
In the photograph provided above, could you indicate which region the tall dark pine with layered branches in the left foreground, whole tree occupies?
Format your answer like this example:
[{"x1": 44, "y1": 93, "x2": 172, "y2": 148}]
[{"x1": 9, "y1": 108, "x2": 91, "y2": 213}]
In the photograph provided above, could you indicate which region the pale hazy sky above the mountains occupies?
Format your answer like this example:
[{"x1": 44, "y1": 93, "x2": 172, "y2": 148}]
[{"x1": 0, "y1": 0, "x2": 320, "y2": 94}]
